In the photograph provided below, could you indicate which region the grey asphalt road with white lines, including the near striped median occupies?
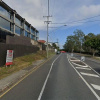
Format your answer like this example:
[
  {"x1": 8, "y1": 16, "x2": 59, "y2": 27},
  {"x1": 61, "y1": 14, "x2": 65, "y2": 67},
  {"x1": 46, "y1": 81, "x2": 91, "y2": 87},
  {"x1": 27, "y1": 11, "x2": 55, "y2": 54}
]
[{"x1": 0, "y1": 53, "x2": 100, "y2": 100}]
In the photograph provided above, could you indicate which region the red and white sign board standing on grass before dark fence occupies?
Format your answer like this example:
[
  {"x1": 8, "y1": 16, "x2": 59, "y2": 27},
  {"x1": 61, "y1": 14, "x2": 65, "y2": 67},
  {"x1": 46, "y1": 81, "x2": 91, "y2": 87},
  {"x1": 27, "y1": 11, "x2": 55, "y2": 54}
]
[{"x1": 6, "y1": 50, "x2": 13, "y2": 67}]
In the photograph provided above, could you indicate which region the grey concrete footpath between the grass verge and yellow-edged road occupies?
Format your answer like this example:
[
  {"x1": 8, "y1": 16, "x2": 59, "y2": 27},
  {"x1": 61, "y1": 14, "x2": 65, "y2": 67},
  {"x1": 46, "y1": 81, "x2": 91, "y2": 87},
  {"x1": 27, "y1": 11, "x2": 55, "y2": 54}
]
[{"x1": 0, "y1": 59, "x2": 46, "y2": 93}]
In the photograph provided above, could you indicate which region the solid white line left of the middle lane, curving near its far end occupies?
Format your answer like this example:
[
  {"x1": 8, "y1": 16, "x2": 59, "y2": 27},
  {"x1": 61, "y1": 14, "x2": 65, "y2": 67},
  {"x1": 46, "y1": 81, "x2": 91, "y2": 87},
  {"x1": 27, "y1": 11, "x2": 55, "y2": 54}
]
[{"x1": 37, "y1": 54, "x2": 61, "y2": 100}]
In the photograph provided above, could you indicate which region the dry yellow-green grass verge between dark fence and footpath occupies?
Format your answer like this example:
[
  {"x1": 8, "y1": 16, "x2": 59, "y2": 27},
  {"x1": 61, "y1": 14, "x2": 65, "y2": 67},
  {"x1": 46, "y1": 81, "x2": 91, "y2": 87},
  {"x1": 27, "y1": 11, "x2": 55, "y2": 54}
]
[{"x1": 0, "y1": 51, "x2": 55, "y2": 79}]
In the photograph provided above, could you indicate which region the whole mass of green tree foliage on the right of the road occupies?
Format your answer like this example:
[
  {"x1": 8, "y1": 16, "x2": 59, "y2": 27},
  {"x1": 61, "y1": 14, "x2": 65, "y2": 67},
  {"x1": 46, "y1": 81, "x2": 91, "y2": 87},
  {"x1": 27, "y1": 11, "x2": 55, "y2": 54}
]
[{"x1": 63, "y1": 29, "x2": 100, "y2": 56}]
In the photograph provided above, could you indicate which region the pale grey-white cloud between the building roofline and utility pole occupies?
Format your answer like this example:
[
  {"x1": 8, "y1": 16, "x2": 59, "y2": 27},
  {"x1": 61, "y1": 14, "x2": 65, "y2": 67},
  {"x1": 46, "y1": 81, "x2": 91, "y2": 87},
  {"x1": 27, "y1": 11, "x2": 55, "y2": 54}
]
[{"x1": 4, "y1": 0, "x2": 47, "y2": 30}]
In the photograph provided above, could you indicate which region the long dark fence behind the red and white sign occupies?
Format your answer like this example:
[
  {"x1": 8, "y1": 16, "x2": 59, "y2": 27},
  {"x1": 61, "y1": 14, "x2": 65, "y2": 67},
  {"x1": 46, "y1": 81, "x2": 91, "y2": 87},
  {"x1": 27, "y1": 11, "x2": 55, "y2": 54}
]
[{"x1": 0, "y1": 43, "x2": 39, "y2": 66}]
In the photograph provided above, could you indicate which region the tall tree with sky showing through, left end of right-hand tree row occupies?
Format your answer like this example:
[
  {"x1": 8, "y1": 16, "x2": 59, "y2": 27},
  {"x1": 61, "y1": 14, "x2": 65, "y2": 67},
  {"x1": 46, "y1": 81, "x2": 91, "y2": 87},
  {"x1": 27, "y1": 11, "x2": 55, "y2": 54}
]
[{"x1": 64, "y1": 29, "x2": 84, "y2": 52}]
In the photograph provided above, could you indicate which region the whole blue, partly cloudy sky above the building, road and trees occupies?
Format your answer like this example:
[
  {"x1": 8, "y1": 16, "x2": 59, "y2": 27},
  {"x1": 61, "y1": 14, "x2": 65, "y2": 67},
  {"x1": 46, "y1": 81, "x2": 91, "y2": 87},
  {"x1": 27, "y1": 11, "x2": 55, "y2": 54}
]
[{"x1": 3, "y1": 0, "x2": 100, "y2": 48}]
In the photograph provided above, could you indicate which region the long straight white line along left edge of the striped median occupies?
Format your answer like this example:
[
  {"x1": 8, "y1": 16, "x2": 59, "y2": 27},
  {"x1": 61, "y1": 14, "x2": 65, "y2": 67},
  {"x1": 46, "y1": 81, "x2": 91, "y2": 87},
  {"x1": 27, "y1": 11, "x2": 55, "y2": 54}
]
[{"x1": 68, "y1": 54, "x2": 100, "y2": 100}]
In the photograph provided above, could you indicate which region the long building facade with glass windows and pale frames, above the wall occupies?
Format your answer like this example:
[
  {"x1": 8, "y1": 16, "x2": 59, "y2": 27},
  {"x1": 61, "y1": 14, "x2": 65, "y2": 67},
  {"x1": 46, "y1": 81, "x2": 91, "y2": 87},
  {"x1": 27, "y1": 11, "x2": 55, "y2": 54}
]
[{"x1": 0, "y1": 0, "x2": 39, "y2": 42}]
